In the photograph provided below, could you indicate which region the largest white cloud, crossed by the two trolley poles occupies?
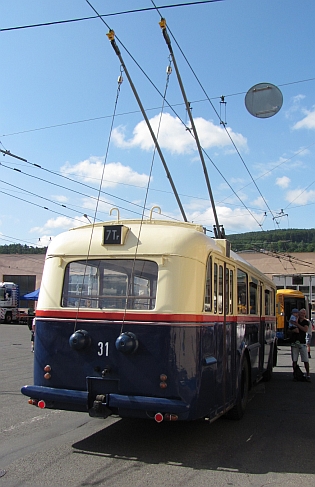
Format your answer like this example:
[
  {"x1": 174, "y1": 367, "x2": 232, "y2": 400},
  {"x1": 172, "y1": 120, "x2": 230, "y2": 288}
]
[{"x1": 112, "y1": 113, "x2": 247, "y2": 154}]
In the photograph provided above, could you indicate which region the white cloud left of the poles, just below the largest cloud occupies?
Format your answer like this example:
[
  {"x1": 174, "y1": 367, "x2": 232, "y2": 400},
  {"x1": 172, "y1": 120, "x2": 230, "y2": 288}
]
[{"x1": 60, "y1": 156, "x2": 149, "y2": 188}]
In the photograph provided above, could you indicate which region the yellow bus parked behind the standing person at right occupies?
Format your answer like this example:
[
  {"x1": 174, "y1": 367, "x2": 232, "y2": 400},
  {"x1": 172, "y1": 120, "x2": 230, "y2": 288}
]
[{"x1": 276, "y1": 289, "x2": 308, "y2": 340}]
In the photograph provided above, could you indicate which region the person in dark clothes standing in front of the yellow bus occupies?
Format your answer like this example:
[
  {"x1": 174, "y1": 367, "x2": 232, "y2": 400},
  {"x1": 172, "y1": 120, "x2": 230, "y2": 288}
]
[{"x1": 291, "y1": 308, "x2": 311, "y2": 382}]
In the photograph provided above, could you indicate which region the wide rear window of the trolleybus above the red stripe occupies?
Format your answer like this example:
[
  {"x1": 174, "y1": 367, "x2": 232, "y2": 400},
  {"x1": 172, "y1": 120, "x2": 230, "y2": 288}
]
[{"x1": 61, "y1": 259, "x2": 158, "y2": 310}]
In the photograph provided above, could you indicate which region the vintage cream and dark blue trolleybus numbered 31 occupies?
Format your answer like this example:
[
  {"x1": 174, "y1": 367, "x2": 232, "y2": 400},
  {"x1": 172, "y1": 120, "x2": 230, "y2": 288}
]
[{"x1": 22, "y1": 212, "x2": 277, "y2": 422}]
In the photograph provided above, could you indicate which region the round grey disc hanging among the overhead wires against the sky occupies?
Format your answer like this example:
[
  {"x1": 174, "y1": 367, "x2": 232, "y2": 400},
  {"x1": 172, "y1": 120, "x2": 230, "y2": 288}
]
[{"x1": 245, "y1": 83, "x2": 283, "y2": 118}]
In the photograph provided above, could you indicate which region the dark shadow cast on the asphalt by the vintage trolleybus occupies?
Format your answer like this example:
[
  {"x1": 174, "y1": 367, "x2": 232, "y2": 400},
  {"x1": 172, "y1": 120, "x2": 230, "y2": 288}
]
[{"x1": 73, "y1": 362, "x2": 315, "y2": 474}]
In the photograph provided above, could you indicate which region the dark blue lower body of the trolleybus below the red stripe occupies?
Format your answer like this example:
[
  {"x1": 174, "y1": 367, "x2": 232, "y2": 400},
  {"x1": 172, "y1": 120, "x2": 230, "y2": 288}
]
[{"x1": 24, "y1": 319, "x2": 273, "y2": 420}]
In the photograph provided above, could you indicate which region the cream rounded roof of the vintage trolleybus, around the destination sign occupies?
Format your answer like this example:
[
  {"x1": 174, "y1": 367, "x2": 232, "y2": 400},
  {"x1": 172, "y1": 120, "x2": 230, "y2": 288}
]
[{"x1": 46, "y1": 220, "x2": 274, "y2": 286}]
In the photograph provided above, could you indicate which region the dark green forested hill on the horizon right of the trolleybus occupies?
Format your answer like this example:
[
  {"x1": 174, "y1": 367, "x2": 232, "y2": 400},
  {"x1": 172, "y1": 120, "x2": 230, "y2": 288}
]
[{"x1": 226, "y1": 228, "x2": 315, "y2": 252}]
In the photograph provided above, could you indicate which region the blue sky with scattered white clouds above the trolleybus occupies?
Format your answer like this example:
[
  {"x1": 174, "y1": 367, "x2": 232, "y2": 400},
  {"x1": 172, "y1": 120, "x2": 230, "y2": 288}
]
[{"x1": 0, "y1": 0, "x2": 315, "y2": 246}]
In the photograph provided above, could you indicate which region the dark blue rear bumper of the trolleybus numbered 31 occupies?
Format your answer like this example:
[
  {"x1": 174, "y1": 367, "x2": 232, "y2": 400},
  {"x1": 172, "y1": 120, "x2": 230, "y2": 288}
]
[{"x1": 21, "y1": 386, "x2": 190, "y2": 420}]
